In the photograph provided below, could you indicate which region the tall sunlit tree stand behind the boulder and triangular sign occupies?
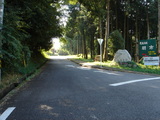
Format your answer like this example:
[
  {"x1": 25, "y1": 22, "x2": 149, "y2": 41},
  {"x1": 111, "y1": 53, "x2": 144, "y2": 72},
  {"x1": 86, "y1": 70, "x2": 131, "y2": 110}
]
[{"x1": 65, "y1": 0, "x2": 158, "y2": 61}]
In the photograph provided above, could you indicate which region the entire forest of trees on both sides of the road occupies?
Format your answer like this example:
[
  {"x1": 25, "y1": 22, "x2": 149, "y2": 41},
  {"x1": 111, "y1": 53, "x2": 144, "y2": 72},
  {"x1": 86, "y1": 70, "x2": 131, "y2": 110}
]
[{"x1": 0, "y1": 0, "x2": 160, "y2": 80}]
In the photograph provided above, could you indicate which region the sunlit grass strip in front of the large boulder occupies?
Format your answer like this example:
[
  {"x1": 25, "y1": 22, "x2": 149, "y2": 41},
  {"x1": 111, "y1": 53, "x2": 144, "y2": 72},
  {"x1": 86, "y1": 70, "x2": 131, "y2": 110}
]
[{"x1": 75, "y1": 58, "x2": 160, "y2": 75}]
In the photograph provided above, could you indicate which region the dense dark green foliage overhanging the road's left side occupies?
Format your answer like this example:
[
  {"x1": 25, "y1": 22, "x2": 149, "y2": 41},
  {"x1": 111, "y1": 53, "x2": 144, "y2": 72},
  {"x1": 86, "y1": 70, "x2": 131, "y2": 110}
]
[{"x1": 1, "y1": 0, "x2": 61, "y2": 73}]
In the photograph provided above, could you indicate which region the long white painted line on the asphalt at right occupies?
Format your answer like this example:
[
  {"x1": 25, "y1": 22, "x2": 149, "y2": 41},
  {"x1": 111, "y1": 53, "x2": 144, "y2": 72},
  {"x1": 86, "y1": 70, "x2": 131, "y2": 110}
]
[{"x1": 110, "y1": 77, "x2": 160, "y2": 87}]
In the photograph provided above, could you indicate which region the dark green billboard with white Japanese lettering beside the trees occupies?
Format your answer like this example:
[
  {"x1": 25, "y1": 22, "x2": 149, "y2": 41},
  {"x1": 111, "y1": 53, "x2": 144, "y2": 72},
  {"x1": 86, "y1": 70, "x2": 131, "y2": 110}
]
[{"x1": 139, "y1": 39, "x2": 157, "y2": 57}]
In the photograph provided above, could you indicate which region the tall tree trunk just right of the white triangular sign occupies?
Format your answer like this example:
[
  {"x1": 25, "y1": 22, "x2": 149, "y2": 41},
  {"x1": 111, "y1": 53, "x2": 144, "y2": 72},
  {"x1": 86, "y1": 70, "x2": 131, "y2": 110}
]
[{"x1": 103, "y1": 0, "x2": 110, "y2": 61}]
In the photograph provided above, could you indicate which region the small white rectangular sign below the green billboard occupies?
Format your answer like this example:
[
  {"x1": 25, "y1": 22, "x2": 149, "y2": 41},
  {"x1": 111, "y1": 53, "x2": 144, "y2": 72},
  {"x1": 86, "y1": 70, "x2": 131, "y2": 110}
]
[{"x1": 143, "y1": 57, "x2": 160, "y2": 65}]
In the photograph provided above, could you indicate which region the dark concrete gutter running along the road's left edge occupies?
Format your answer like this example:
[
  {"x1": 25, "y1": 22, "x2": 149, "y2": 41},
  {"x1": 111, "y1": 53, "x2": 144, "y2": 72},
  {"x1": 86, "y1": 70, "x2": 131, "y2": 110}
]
[{"x1": 0, "y1": 60, "x2": 48, "y2": 100}]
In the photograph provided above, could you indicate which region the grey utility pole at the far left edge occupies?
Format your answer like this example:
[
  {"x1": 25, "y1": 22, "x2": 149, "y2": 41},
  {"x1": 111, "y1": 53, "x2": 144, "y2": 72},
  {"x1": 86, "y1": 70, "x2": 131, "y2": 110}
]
[{"x1": 0, "y1": 0, "x2": 4, "y2": 83}]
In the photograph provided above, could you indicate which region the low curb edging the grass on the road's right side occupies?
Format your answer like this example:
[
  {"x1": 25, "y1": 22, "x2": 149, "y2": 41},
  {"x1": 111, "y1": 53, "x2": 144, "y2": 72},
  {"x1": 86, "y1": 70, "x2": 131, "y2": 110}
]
[{"x1": 69, "y1": 59, "x2": 160, "y2": 76}]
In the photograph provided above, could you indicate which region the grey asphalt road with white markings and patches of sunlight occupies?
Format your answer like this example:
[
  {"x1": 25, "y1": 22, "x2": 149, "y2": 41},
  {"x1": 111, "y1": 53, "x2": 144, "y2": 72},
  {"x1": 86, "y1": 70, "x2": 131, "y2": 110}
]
[{"x1": 0, "y1": 56, "x2": 160, "y2": 120}]
